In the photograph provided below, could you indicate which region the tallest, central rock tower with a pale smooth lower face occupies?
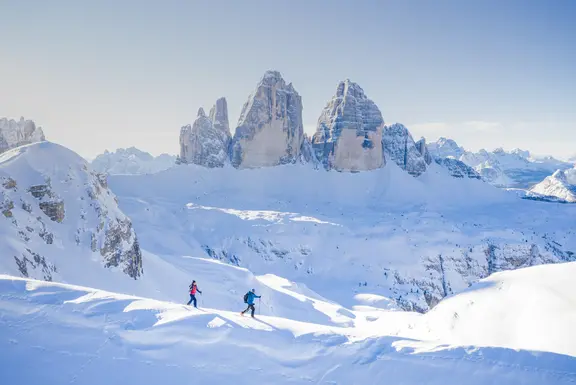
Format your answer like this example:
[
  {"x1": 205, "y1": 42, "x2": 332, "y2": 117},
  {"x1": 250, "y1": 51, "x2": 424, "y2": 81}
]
[{"x1": 230, "y1": 71, "x2": 304, "y2": 168}]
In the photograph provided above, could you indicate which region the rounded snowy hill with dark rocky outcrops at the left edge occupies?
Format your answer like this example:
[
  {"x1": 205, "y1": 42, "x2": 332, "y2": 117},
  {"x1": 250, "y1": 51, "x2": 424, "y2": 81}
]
[{"x1": 0, "y1": 142, "x2": 142, "y2": 282}]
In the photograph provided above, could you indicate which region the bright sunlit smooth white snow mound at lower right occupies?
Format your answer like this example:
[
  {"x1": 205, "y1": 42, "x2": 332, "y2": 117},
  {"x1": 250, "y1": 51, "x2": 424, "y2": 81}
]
[{"x1": 416, "y1": 262, "x2": 576, "y2": 356}]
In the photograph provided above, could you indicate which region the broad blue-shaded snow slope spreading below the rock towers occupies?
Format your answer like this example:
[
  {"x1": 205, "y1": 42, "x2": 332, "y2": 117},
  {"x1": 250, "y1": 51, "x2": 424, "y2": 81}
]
[{"x1": 110, "y1": 162, "x2": 576, "y2": 311}]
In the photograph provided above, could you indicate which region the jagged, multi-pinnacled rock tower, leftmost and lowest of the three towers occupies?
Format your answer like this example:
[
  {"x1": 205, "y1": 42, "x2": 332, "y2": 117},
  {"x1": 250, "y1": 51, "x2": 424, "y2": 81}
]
[{"x1": 179, "y1": 98, "x2": 230, "y2": 167}]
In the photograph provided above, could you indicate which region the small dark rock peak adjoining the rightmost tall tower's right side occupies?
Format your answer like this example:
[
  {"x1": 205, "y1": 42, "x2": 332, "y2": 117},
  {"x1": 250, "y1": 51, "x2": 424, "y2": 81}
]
[{"x1": 382, "y1": 123, "x2": 427, "y2": 176}]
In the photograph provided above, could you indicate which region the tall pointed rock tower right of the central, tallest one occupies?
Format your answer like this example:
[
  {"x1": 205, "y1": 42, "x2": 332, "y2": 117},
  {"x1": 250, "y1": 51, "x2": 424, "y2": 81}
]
[{"x1": 312, "y1": 79, "x2": 385, "y2": 171}]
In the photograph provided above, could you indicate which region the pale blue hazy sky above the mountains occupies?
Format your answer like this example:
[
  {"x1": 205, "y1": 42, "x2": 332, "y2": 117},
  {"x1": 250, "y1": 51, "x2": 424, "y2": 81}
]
[{"x1": 0, "y1": 0, "x2": 576, "y2": 158}]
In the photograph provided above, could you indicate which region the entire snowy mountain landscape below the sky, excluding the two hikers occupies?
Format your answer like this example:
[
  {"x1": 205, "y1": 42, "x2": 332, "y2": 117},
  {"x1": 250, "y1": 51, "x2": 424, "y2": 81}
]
[{"x1": 0, "y1": 71, "x2": 576, "y2": 385}]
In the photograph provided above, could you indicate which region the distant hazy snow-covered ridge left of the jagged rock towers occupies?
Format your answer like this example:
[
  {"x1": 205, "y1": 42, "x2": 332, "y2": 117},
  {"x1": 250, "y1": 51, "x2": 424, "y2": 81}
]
[{"x1": 91, "y1": 147, "x2": 176, "y2": 175}]
